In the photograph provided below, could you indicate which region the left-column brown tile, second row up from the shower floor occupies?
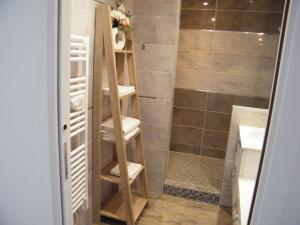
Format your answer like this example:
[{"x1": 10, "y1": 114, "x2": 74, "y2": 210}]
[{"x1": 171, "y1": 125, "x2": 202, "y2": 146}]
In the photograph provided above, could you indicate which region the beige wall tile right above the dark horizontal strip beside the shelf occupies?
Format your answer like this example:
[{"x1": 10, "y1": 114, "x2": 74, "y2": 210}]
[{"x1": 137, "y1": 70, "x2": 175, "y2": 99}]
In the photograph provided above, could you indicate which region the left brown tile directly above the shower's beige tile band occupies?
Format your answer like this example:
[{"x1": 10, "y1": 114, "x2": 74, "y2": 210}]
[{"x1": 180, "y1": 9, "x2": 215, "y2": 30}]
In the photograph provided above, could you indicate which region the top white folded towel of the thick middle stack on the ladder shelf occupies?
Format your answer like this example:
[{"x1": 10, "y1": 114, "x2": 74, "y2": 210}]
[{"x1": 101, "y1": 116, "x2": 141, "y2": 135}]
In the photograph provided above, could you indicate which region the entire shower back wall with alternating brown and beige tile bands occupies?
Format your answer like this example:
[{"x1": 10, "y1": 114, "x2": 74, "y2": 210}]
[{"x1": 171, "y1": 0, "x2": 284, "y2": 158}]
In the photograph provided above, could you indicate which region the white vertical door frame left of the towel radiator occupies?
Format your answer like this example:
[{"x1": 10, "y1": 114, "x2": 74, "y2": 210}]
[{"x1": 57, "y1": 0, "x2": 73, "y2": 225}]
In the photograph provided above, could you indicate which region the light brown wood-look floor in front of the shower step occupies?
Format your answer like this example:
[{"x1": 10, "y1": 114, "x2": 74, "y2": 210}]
[{"x1": 102, "y1": 194, "x2": 232, "y2": 225}]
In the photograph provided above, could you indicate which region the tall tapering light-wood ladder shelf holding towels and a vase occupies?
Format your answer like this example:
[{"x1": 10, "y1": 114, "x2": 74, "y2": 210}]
[{"x1": 93, "y1": 5, "x2": 148, "y2": 225}]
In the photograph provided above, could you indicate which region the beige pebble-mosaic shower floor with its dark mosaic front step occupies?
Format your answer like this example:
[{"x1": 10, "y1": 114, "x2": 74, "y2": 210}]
[{"x1": 164, "y1": 151, "x2": 224, "y2": 204}]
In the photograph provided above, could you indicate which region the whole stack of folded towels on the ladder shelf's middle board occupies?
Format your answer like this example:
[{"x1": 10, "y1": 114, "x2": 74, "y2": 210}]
[{"x1": 101, "y1": 116, "x2": 141, "y2": 141}]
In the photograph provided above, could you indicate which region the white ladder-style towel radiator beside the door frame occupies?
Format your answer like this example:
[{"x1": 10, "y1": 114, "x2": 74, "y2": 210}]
[{"x1": 70, "y1": 35, "x2": 89, "y2": 213}]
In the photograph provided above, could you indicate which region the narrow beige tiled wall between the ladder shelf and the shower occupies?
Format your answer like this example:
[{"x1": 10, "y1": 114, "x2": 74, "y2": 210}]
[{"x1": 133, "y1": 0, "x2": 180, "y2": 192}]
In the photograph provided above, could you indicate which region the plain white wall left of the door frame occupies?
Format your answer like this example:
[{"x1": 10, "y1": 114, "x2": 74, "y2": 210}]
[{"x1": 0, "y1": 0, "x2": 61, "y2": 225}]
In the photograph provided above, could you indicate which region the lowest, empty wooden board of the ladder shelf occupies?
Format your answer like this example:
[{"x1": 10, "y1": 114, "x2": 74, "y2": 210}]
[{"x1": 100, "y1": 192, "x2": 148, "y2": 222}]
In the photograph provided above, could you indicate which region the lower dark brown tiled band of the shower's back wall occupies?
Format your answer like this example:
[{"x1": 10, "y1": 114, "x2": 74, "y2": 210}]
[{"x1": 170, "y1": 88, "x2": 268, "y2": 159}]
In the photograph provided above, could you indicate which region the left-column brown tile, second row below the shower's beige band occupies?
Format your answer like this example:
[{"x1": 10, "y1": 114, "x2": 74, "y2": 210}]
[{"x1": 172, "y1": 107, "x2": 205, "y2": 128}]
